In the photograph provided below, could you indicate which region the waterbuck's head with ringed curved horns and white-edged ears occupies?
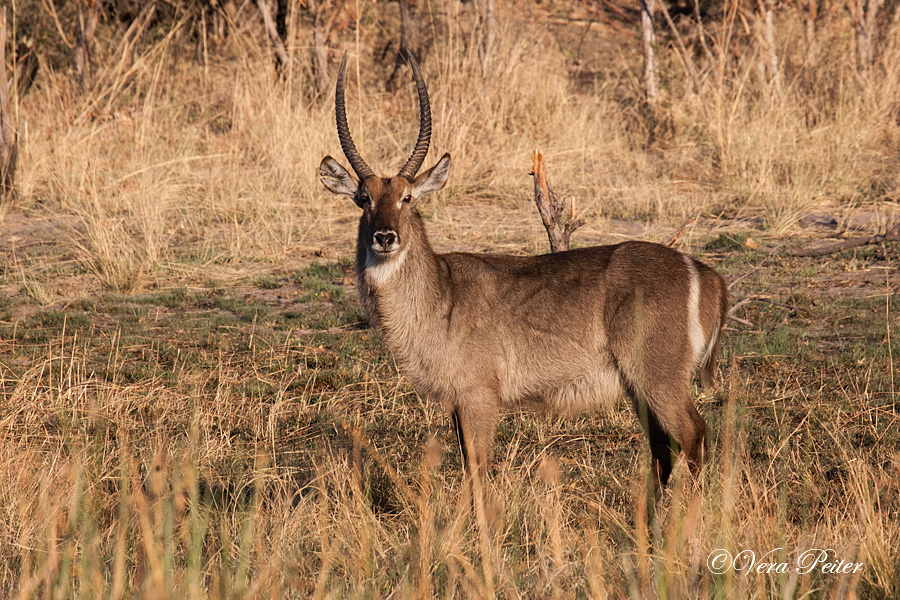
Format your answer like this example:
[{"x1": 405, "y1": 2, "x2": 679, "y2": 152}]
[{"x1": 319, "y1": 52, "x2": 450, "y2": 263}]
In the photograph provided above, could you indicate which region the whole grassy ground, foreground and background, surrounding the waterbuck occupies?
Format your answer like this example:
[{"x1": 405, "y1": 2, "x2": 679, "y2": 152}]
[{"x1": 0, "y1": 2, "x2": 900, "y2": 598}]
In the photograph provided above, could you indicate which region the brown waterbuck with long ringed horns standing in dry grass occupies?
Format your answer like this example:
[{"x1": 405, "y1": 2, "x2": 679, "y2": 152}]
[{"x1": 319, "y1": 53, "x2": 728, "y2": 486}]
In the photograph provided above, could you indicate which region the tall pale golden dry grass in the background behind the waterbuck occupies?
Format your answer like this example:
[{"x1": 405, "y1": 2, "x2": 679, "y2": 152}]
[{"x1": 8, "y1": 3, "x2": 900, "y2": 291}]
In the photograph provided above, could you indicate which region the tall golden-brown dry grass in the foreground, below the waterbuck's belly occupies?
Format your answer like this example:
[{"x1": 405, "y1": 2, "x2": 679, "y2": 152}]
[{"x1": 0, "y1": 304, "x2": 900, "y2": 598}]
